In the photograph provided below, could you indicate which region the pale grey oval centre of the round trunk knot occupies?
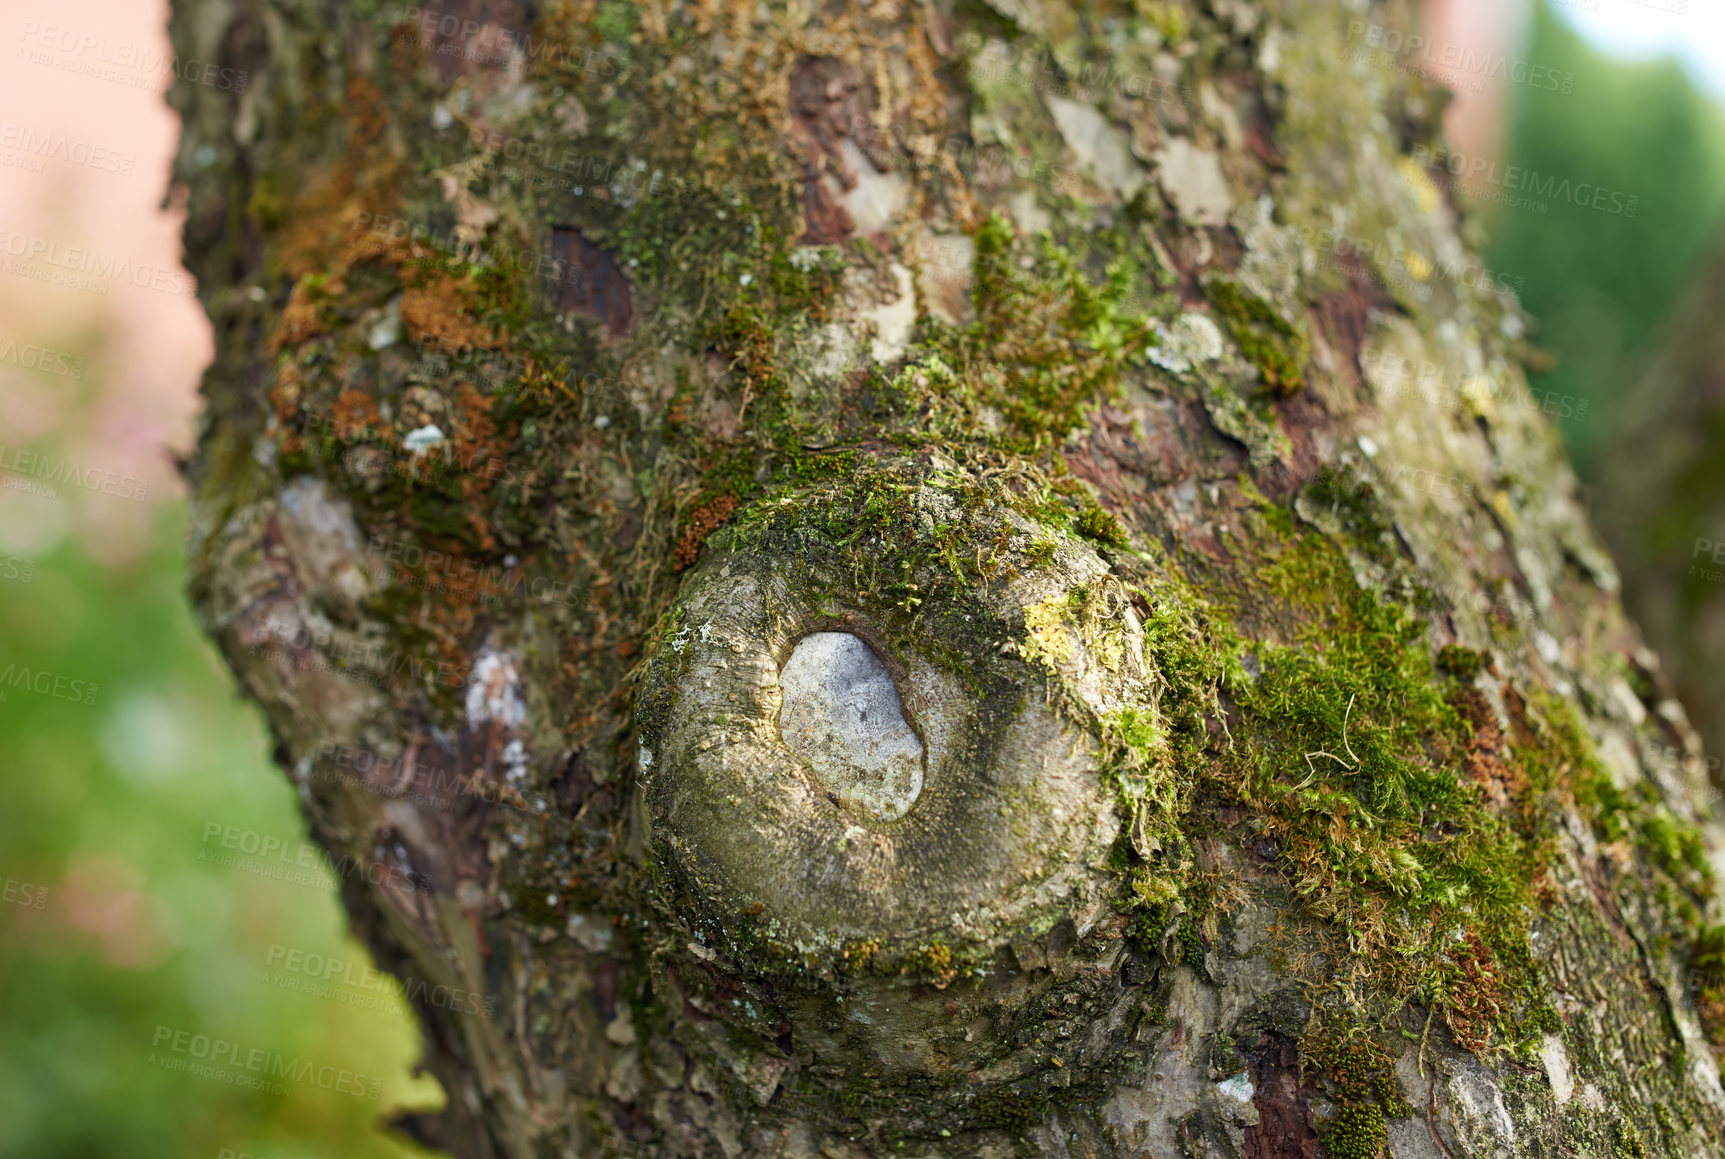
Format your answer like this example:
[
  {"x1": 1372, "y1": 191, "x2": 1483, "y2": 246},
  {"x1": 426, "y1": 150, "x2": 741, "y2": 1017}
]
[{"x1": 778, "y1": 631, "x2": 923, "y2": 821}]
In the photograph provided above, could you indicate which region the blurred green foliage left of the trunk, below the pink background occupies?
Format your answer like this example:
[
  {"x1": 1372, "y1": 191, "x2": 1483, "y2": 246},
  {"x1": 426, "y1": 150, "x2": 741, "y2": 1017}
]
[{"x1": 0, "y1": 510, "x2": 442, "y2": 1159}]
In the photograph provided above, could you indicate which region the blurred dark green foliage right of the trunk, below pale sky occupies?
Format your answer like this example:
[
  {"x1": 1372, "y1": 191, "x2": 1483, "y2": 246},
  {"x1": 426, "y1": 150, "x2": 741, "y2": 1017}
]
[{"x1": 1482, "y1": 3, "x2": 1725, "y2": 474}]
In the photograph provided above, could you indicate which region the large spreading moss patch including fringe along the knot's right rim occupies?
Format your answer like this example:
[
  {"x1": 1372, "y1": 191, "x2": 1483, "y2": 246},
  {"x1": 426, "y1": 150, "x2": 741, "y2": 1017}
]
[{"x1": 1102, "y1": 474, "x2": 1580, "y2": 1069}]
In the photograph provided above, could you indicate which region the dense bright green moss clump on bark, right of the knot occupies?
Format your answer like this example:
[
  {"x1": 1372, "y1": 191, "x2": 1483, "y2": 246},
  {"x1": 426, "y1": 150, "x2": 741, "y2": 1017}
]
[{"x1": 1223, "y1": 538, "x2": 1553, "y2": 1049}]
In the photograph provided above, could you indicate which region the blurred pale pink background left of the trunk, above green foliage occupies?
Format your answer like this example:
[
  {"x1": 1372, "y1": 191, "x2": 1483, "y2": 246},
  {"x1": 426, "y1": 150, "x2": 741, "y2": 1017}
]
[{"x1": 0, "y1": 0, "x2": 212, "y2": 566}]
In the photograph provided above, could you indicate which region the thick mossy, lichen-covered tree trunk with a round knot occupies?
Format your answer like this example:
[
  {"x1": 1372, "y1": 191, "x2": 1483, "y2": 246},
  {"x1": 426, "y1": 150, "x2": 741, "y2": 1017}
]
[{"x1": 173, "y1": 0, "x2": 1725, "y2": 1159}]
